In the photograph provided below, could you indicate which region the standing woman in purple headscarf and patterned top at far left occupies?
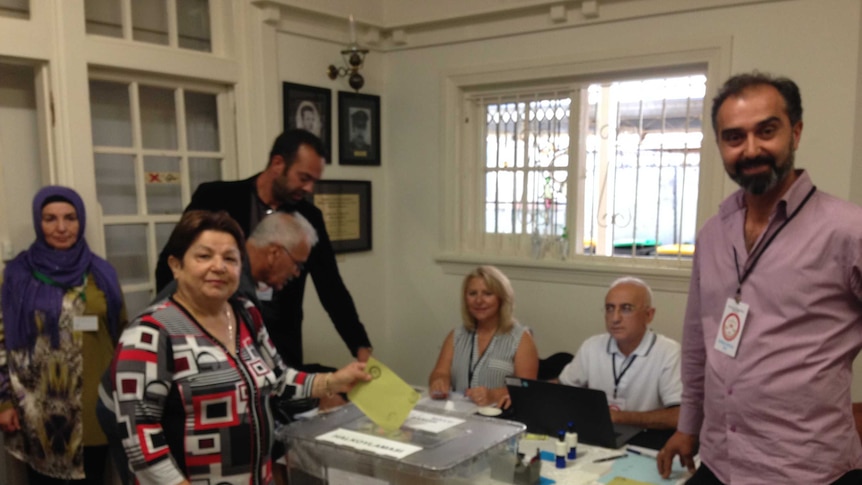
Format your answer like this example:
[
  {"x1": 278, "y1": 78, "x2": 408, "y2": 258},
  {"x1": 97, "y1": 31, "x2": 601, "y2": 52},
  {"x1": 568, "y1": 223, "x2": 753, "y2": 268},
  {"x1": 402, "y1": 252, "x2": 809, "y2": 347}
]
[{"x1": 0, "y1": 186, "x2": 127, "y2": 485}]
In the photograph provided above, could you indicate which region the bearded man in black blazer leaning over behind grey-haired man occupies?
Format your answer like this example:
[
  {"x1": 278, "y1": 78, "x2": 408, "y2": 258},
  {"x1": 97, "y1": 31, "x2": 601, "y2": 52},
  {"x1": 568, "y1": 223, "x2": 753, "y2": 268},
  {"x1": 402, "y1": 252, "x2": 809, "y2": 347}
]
[{"x1": 156, "y1": 130, "x2": 371, "y2": 369}]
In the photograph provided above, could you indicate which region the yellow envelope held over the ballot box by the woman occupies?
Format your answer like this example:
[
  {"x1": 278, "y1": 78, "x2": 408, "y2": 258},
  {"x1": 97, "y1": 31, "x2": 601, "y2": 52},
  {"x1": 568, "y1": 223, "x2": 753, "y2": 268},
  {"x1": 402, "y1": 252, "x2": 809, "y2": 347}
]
[{"x1": 347, "y1": 357, "x2": 419, "y2": 431}]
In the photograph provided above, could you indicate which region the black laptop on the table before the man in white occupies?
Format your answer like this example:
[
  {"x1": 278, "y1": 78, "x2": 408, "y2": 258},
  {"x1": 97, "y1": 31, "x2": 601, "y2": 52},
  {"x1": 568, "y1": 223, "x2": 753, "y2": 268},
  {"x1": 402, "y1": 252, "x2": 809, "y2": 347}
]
[{"x1": 500, "y1": 377, "x2": 642, "y2": 448}]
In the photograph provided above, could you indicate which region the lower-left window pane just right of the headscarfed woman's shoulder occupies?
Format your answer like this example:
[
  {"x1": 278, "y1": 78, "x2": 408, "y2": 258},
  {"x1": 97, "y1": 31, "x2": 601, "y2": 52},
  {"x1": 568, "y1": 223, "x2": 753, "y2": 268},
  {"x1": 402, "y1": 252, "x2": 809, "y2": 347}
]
[{"x1": 105, "y1": 224, "x2": 150, "y2": 285}]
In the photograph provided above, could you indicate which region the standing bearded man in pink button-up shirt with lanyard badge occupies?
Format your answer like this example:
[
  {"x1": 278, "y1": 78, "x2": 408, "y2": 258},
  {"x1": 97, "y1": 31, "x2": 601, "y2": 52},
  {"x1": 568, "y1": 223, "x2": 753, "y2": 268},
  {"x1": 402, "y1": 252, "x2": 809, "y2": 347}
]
[{"x1": 658, "y1": 72, "x2": 862, "y2": 485}]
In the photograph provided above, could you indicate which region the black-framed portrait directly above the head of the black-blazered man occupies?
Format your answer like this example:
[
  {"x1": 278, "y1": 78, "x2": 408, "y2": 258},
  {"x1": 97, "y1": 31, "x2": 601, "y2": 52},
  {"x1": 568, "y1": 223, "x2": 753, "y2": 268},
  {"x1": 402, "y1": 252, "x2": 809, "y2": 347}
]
[{"x1": 281, "y1": 83, "x2": 332, "y2": 163}]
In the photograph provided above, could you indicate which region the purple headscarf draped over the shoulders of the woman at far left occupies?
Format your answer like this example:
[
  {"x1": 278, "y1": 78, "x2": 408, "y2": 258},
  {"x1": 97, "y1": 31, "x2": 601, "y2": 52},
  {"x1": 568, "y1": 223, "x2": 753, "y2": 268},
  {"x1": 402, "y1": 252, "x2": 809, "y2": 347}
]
[{"x1": 2, "y1": 185, "x2": 123, "y2": 349}]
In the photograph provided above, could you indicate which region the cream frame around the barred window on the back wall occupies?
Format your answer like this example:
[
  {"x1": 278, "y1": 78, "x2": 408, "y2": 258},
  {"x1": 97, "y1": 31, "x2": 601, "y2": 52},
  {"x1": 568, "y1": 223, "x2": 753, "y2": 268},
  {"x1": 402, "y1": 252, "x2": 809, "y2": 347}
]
[{"x1": 435, "y1": 39, "x2": 731, "y2": 292}]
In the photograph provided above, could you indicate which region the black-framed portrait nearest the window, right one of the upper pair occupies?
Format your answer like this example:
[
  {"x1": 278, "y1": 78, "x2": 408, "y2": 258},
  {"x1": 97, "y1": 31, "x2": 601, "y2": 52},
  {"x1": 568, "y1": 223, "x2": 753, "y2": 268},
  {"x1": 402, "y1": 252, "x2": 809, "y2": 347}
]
[{"x1": 338, "y1": 91, "x2": 380, "y2": 165}]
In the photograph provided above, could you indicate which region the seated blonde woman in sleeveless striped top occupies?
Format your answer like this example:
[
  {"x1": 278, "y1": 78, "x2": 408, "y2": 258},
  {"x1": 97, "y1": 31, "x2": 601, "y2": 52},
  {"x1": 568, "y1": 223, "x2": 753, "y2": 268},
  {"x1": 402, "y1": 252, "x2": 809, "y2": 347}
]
[{"x1": 428, "y1": 266, "x2": 539, "y2": 409}]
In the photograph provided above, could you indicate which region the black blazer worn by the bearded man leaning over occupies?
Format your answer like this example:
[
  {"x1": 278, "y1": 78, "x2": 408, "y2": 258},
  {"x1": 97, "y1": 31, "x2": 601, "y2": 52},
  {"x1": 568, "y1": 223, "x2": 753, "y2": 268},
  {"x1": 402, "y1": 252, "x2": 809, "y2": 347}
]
[{"x1": 156, "y1": 174, "x2": 371, "y2": 368}]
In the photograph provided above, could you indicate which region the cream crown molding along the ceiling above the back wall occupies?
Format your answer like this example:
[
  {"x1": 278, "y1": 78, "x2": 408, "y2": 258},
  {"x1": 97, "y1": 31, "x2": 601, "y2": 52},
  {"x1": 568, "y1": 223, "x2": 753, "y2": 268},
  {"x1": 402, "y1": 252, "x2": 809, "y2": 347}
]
[{"x1": 252, "y1": 0, "x2": 790, "y2": 52}]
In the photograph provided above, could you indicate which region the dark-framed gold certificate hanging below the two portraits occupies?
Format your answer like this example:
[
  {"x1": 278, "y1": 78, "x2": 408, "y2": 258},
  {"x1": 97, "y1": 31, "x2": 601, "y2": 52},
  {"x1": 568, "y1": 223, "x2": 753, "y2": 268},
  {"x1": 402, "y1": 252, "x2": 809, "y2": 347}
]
[{"x1": 312, "y1": 180, "x2": 371, "y2": 253}]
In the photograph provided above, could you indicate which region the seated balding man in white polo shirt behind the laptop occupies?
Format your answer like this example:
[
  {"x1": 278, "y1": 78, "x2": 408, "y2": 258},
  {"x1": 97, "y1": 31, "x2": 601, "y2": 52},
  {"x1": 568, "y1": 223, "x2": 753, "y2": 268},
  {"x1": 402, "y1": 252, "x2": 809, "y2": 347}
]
[{"x1": 559, "y1": 276, "x2": 682, "y2": 429}]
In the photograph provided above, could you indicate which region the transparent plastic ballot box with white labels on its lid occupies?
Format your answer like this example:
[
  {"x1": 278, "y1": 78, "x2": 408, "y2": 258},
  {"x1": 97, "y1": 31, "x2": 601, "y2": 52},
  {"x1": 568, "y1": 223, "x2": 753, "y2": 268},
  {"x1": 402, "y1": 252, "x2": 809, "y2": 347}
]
[{"x1": 277, "y1": 404, "x2": 526, "y2": 485}]
